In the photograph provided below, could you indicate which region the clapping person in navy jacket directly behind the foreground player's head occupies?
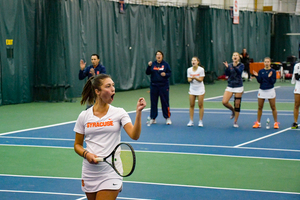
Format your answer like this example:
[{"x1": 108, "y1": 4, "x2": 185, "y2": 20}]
[{"x1": 79, "y1": 54, "x2": 106, "y2": 80}]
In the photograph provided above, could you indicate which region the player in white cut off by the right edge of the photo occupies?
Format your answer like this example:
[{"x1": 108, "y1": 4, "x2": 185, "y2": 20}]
[{"x1": 291, "y1": 63, "x2": 300, "y2": 129}]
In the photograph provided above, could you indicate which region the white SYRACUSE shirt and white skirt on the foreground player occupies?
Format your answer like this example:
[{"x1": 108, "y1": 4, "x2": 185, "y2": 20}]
[{"x1": 74, "y1": 105, "x2": 131, "y2": 193}]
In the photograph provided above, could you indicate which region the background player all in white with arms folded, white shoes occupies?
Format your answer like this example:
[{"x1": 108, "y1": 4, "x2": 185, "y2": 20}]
[{"x1": 187, "y1": 57, "x2": 205, "y2": 127}]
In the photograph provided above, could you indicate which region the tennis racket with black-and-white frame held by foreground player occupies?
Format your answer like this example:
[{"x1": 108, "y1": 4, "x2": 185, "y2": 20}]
[{"x1": 96, "y1": 143, "x2": 135, "y2": 177}]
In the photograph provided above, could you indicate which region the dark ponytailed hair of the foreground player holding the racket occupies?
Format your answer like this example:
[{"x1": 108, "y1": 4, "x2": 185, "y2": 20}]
[{"x1": 80, "y1": 74, "x2": 111, "y2": 105}]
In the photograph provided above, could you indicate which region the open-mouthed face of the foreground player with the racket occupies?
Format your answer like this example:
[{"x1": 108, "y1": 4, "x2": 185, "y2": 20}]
[{"x1": 96, "y1": 78, "x2": 116, "y2": 104}]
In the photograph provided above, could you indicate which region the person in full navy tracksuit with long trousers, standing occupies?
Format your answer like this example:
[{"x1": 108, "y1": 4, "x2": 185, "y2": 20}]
[{"x1": 146, "y1": 51, "x2": 172, "y2": 125}]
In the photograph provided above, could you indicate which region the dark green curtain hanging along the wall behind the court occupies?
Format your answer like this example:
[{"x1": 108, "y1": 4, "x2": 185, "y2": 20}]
[{"x1": 0, "y1": 0, "x2": 300, "y2": 105}]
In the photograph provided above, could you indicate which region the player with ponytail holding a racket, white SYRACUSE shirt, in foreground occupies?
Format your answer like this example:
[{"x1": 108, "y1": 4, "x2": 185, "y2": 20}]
[{"x1": 74, "y1": 74, "x2": 146, "y2": 200}]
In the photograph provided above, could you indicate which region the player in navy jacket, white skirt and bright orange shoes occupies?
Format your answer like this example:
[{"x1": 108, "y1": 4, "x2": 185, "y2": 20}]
[{"x1": 253, "y1": 57, "x2": 279, "y2": 129}]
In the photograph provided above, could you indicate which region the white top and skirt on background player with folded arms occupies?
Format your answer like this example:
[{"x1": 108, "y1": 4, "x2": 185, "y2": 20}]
[{"x1": 187, "y1": 66, "x2": 205, "y2": 96}]
